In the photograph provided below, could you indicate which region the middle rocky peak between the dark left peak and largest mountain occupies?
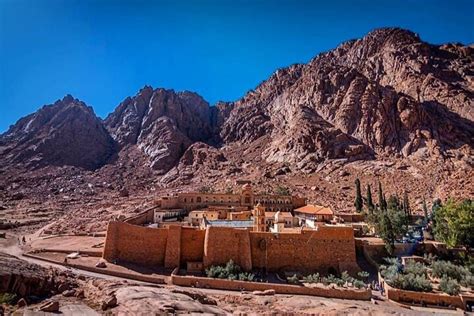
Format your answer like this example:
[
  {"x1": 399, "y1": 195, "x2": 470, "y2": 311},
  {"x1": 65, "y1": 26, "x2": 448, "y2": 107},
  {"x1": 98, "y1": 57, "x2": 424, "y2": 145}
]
[{"x1": 105, "y1": 86, "x2": 226, "y2": 173}]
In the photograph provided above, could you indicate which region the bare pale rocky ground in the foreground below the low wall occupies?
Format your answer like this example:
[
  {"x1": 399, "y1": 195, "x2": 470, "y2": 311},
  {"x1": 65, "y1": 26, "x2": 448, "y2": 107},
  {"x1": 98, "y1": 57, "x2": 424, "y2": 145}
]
[{"x1": 0, "y1": 248, "x2": 440, "y2": 315}]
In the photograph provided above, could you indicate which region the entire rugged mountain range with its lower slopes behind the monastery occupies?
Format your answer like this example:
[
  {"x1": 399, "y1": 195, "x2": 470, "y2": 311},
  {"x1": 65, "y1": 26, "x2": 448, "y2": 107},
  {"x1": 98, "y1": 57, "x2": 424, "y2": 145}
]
[{"x1": 0, "y1": 28, "x2": 474, "y2": 209}]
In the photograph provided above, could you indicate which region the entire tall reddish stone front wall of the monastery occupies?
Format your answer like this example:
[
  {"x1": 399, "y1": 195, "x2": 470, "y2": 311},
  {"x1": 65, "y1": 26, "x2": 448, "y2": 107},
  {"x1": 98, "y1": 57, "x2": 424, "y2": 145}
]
[{"x1": 103, "y1": 222, "x2": 360, "y2": 273}]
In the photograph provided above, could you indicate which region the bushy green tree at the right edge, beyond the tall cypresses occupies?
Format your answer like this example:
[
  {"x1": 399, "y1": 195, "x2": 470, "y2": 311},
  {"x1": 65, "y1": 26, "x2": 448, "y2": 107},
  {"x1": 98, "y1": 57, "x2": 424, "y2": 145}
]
[{"x1": 433, "y1": 199, "x2": 474, "y2": 248}]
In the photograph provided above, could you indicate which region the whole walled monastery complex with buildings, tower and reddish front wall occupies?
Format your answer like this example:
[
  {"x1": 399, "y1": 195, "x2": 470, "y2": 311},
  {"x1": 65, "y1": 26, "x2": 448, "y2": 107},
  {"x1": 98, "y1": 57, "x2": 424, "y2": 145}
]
[{"x1": 103, "y1": 184, "x2": 359, "y2": 273}]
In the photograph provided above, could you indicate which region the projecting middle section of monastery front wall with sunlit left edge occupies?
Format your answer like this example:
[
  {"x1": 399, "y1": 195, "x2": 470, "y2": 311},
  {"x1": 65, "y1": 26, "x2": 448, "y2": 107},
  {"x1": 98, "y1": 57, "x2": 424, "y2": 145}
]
[{"x1": 203, "y1": 226, "x2": 252, "y2": 270}]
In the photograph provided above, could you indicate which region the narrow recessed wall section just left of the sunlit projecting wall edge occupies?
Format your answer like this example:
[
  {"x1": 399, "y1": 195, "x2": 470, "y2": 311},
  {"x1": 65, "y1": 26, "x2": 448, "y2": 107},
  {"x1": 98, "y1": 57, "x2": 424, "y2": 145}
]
[{"x1": 180, "y1": 227, "x2": 206, "y2": 266}]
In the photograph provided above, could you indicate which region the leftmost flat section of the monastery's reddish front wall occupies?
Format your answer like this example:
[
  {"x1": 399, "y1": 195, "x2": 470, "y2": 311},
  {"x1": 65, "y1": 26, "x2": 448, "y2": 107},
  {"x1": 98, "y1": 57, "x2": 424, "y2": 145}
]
[{"x1": 103, "y1": 222, "x2": 168, "y2": 266}]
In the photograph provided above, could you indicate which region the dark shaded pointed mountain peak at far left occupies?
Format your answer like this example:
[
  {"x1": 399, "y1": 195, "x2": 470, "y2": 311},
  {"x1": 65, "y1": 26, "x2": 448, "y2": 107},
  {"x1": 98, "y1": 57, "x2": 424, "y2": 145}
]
[{"x1": 0, "y1": 95, "x2": 116, "y2": 170}]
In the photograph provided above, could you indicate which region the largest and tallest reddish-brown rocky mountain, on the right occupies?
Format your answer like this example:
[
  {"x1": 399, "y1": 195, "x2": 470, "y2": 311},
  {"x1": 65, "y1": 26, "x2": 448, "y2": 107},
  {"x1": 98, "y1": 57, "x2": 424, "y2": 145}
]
[{"x1": 221, "y1": 29, "x2": 474, "y2": 171}]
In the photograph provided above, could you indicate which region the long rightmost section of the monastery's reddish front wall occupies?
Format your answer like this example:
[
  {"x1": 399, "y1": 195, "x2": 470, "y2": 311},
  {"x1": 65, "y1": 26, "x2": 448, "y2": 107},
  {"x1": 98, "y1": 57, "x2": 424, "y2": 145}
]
[{"x1": 250, "y1": 227, "x2": 358, "y2": 273}]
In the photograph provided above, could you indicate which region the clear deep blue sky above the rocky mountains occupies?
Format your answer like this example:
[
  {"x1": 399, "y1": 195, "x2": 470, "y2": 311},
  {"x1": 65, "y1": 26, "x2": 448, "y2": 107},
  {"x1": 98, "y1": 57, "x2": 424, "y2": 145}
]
[{"x1": 0, "y1": 0, "x2": 474, "y2": 132}]
